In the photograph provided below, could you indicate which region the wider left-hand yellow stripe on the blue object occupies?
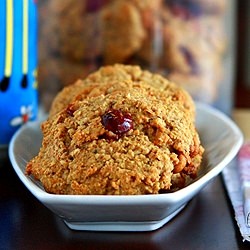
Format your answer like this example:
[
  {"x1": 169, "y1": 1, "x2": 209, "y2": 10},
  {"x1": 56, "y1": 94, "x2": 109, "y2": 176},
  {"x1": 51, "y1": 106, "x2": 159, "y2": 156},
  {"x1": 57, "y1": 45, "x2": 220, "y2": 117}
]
[{"x1": 4, "y1": 0, "x2": 13, "y2": 76}]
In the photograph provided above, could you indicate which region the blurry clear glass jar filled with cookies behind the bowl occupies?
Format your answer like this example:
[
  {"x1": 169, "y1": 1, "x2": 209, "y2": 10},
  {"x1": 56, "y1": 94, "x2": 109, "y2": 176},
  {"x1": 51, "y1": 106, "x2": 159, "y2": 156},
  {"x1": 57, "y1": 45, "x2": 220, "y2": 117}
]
[{"x1": 38, "y1": 0, "x2": 235, "y2": 114}]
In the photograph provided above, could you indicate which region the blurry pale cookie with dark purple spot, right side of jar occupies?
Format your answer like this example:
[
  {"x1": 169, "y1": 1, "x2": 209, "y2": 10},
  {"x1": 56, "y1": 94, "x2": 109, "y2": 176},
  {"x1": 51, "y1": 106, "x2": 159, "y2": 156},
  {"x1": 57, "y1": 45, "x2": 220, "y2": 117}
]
[{"x1": 162, "y1": 11, "x2": 226, "y2": 103}]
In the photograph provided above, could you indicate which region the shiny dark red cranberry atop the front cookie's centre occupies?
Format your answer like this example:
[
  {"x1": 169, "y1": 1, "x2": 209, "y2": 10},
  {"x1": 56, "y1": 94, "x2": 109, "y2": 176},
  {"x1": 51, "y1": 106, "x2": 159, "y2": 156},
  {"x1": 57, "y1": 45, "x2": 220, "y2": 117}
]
[{"x1": 101, "y1": 109, "x2": 133, "y2": 137}]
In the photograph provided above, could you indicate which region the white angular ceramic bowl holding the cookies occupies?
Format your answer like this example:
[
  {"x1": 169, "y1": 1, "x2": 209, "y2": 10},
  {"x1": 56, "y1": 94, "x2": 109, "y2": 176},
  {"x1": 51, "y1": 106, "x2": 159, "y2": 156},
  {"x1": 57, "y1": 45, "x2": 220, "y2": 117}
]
[{"x1": 9, "y1": 104, "x2": 243, "y2": 231}]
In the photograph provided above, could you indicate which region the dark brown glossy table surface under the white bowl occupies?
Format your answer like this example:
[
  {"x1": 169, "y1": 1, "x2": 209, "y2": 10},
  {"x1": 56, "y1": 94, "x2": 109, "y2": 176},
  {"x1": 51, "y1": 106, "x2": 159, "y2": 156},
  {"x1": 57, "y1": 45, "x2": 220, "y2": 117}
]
[{"x1": 0, "y1": 157, "x2": 250, "y2": 250}]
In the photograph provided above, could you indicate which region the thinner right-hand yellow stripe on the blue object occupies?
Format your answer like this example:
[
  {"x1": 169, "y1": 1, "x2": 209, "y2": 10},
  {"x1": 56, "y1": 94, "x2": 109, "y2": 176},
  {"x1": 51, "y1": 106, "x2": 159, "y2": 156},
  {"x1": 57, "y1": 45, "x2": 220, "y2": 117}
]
[{"x1": 23, "y1": 0, "x2": 29, "y2": 74}]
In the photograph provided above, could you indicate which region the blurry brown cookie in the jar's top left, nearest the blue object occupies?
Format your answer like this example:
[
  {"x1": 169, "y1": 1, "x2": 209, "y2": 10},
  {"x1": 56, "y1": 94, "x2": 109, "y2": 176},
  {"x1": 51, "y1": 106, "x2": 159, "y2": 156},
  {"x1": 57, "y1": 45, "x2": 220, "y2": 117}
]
[{"x1": 39, "y1": 0, "x2": 102, "y2": 63}]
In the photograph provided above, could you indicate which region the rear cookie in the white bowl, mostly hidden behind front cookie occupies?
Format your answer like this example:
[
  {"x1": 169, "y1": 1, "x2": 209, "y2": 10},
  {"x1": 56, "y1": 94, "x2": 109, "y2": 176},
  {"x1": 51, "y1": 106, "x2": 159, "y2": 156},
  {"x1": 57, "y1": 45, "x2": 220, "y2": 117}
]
[{"x1": 50, "y1": 64, "x2": 194, "y2": 116}]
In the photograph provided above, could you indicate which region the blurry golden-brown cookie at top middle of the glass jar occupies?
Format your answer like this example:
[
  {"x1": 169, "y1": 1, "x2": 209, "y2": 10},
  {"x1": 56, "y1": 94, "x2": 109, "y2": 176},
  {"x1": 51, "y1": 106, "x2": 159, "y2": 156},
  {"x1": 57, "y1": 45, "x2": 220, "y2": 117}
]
[{"x1": 100, "y1": 0, "x2": 145, "y2": 64}]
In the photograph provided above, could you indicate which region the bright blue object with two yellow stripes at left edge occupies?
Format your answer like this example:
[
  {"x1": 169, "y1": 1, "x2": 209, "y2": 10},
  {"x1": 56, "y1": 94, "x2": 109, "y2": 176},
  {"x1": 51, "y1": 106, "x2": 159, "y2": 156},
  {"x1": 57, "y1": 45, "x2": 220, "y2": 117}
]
[{"x1": 0, "y1": 0, "x2": 38, "y2": 146}]
